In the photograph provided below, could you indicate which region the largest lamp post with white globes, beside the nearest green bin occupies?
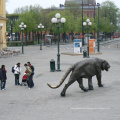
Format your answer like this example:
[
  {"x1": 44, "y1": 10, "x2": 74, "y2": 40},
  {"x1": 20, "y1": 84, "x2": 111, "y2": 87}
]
[{"x1": 51, "y1": 13, "x2": 66, "y2": 71}]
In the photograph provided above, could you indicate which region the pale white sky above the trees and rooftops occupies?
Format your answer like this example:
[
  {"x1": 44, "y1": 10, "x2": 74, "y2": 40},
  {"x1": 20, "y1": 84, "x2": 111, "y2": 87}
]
[{"x1": 6, "y1": 0, "x2": 120, "y2": 14}]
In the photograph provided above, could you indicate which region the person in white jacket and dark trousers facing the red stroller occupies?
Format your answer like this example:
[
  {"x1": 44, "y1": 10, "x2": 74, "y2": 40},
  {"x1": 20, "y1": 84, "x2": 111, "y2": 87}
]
[{"x1": 14, "y1": 63, "x2": 21, "y2": 85}]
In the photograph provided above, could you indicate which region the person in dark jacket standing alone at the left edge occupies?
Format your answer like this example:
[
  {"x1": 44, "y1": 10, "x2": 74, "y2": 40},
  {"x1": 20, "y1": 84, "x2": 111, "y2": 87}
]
[{"x1": 0, "y1": 65, "x2": 7, "y2": 90}]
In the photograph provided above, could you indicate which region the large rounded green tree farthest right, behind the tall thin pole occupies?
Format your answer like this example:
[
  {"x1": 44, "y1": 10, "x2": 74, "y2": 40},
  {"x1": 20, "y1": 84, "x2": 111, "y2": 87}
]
[{"x1": 100, "y1": 0, "x2": 119, "y2": 33}]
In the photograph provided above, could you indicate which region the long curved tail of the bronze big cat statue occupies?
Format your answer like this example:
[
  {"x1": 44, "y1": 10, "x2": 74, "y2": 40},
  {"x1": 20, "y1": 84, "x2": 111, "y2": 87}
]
[{"x1": 47, "y1": 65, "x2": 75, "y2": 89}]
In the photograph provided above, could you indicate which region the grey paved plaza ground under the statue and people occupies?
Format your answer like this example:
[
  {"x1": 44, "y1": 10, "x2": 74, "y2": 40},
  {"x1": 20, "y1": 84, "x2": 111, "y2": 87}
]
[{"x1": 0, "y1": 41, "x2": 120, "y2": 120}]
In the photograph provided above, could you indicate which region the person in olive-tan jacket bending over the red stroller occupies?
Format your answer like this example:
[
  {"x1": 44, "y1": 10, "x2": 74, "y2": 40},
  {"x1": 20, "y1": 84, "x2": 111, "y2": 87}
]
[{"x1": 24, "y1": 64, "x2": 33, "y2": 89}]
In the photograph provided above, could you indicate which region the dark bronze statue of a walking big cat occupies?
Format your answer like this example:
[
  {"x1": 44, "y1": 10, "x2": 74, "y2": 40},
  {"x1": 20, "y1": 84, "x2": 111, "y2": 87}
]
[{"x1": 47, "y1": 58, "x2": 110, "y2": 96}]
